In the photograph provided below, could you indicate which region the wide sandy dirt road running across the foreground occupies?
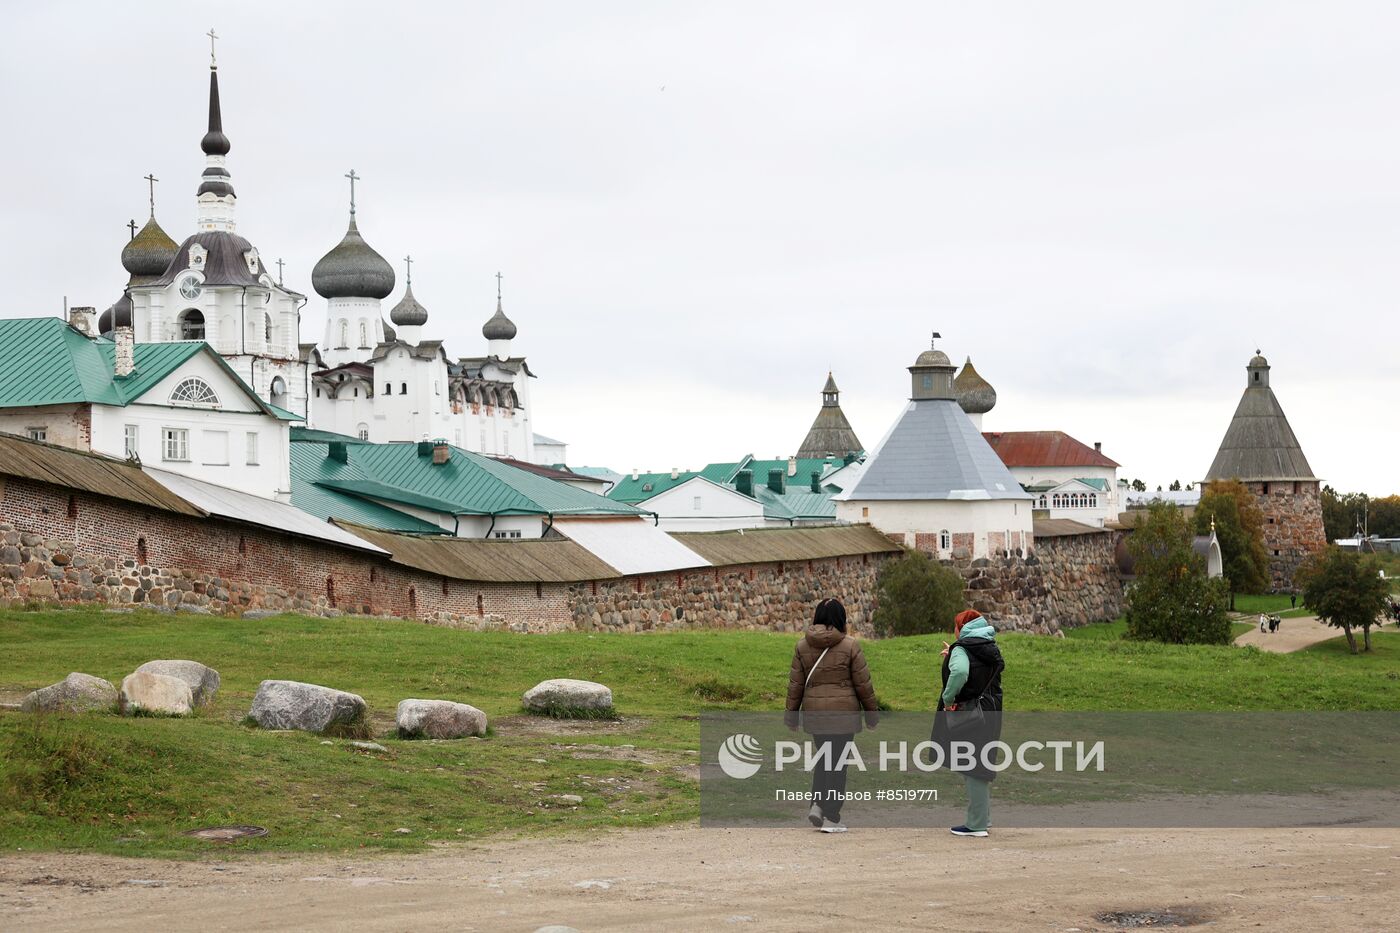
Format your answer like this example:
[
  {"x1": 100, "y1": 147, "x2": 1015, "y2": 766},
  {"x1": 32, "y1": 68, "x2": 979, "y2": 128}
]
[{"x1": 0, "y1": 825, "x2": 1400, "y2": 933}]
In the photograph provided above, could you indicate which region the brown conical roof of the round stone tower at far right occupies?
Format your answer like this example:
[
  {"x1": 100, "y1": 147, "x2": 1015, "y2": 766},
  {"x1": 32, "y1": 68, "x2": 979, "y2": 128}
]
[{"x1": 1205, "y1": 348, "x2": 1317, "y2": 482}]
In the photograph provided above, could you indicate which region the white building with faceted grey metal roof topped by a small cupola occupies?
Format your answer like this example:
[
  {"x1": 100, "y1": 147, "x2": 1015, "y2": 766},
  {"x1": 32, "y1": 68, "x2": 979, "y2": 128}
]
[{"x1": 834, "y1": 336, "x2": 1035, "y2": 558}]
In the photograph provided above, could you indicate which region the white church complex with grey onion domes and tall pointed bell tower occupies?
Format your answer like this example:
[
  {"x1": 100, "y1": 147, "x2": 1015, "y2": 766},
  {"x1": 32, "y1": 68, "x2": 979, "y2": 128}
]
[{"x1": 98, "y1": 44, "x2": 543, "y2": 462}]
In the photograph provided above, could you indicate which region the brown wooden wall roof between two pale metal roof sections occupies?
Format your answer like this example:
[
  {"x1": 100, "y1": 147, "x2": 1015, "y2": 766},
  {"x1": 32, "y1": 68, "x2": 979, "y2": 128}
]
[{"x1": 336, "y1": 521, "x2": 622, "y2": 583}]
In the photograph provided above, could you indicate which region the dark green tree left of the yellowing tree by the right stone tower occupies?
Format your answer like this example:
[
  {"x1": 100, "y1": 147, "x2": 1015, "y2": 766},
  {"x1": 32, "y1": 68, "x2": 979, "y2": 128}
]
[{"x1": 1127, "y1": 503, "x2": 1231, "y2": 644}]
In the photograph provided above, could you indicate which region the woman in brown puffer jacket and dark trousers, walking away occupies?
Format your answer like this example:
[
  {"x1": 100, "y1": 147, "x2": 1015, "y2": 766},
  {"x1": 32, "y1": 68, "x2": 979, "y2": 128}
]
[{"x1": 785, "y1": 600, "x2": 879, "y2": 832}]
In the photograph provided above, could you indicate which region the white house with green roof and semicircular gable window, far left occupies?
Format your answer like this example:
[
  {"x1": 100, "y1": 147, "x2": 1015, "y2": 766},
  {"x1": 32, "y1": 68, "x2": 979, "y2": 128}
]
[{"x1": 0, "y1": 308, "x2": 300, "y2": 502}]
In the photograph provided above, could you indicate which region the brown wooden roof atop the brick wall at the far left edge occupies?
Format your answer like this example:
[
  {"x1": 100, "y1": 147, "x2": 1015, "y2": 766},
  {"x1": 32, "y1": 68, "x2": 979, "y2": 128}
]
[{"x1": 0, "y1": 433, "x2": 206, "y2": 517}]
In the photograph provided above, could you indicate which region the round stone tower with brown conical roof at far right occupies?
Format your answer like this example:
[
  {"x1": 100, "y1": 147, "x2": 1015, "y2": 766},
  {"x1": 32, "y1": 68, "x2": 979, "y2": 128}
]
[{"x1": 1201, "y1": 350, "x2": 1327, "y2": 590}]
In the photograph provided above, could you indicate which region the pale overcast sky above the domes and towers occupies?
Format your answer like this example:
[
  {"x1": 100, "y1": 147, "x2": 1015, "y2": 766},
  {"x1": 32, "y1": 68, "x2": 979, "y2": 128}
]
[{"x1": 0, "y1": 0, "x2": 1400, "y2": 493}]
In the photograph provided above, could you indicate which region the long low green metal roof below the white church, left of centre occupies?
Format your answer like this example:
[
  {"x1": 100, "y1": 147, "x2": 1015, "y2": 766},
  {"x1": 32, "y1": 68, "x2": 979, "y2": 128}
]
[{"x1": 291, "y1": 440, "x2": 644, "y2": 527}]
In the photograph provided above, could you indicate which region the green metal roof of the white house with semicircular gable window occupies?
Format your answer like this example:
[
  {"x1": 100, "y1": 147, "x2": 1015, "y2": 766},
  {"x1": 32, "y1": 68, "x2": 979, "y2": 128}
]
[{"x1": 0, "y1": 318, "x2": 302, "y2": 420}]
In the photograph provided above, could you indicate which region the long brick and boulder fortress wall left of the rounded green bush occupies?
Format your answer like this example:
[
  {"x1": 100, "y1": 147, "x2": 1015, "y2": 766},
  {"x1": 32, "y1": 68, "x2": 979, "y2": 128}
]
[{"x1": 0, "y1": 478, "x2": 883, "y2": 632}]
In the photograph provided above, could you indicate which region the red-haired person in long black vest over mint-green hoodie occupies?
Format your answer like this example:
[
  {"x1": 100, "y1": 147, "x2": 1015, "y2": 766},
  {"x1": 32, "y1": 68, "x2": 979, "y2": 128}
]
[{"x1": 934, "y1": 609, "x2": 1005, "y2": 836}]
